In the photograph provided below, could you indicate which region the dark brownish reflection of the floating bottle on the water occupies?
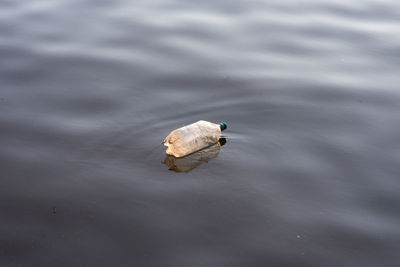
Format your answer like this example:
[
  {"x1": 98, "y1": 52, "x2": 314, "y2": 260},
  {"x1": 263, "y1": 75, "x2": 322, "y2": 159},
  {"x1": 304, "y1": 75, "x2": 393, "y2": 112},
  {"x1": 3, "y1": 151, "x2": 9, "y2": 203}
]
[{"x1": 164, "y1": 137, "x2": 226, "y2": 172}]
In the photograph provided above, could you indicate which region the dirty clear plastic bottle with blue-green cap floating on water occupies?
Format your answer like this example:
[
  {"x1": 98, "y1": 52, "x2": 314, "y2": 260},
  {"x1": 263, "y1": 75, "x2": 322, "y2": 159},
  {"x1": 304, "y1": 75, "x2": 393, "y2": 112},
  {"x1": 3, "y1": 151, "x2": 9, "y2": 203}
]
[{"x1": 164, "y1": 120, "x2": 227, "y2": 158}]
